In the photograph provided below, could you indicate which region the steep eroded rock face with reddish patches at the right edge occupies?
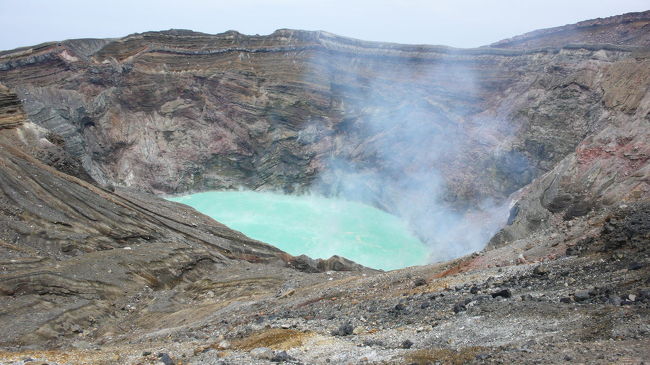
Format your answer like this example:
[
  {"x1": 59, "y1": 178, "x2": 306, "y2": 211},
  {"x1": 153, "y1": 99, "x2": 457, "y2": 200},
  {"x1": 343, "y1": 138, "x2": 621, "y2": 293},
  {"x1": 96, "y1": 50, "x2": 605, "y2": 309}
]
[{"x1": 491, "y1": 55, "x2": 650, "y2": 245}]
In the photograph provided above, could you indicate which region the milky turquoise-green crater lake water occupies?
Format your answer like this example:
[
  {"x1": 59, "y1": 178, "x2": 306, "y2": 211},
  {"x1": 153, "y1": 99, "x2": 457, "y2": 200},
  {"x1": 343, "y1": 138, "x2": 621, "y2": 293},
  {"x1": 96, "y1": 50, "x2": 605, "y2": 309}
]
[{"x1": 169, "y1": 191, "x2": 429, "y2": 270}]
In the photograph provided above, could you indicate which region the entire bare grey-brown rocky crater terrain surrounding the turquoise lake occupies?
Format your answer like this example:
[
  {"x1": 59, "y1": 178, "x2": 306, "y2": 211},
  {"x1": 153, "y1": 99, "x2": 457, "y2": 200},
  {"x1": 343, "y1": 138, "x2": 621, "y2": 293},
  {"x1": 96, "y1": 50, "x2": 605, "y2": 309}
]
[{"x1": 0, "y1": 12, "x2": 650, "y2": 363}]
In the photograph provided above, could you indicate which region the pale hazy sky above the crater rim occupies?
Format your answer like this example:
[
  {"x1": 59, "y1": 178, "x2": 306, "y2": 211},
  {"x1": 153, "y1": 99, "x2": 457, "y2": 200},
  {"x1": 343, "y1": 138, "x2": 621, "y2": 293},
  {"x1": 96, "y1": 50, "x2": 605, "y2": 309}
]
[{"x1": 0, "y1": 0, "x2": 650, "y2": 49}]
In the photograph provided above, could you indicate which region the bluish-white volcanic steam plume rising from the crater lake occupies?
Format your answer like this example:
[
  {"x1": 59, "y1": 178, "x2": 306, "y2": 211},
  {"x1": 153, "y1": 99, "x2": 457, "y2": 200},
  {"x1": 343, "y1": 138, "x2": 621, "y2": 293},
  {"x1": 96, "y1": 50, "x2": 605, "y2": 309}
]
[{"x1": 306, "y1": 49, "x2": 527, "y2": 261}]
